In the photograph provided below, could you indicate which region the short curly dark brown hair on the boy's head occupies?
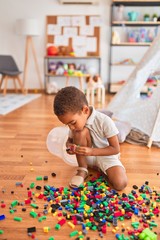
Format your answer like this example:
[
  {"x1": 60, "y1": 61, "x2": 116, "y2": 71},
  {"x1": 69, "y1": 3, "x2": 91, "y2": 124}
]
[{"x1": 53, "y1": 87, "x2": 88, "y2": 116}]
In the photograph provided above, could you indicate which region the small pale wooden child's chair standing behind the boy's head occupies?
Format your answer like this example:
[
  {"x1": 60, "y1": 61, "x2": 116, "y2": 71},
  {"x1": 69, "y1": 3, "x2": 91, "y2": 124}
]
[{"x1": 86, "y1": 75, "x2": 105, "y2": 105}]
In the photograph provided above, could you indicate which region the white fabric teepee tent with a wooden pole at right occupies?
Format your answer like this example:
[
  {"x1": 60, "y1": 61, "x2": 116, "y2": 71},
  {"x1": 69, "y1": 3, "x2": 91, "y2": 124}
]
[{"x1": 107, "y1": 31, "x2": 160, "y2": 147}]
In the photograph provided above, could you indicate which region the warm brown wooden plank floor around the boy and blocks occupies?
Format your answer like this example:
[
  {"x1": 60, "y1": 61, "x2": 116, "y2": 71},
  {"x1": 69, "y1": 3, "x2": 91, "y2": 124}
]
[{"x1": 0, "y1": 95, "x2": 160, "y2": 240}]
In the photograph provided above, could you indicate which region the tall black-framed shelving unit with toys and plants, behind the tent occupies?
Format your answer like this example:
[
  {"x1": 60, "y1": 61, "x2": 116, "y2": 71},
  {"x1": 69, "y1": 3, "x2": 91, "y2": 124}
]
[{"x1": 108, "y1": 0, "x2": 160, "y2": 93}]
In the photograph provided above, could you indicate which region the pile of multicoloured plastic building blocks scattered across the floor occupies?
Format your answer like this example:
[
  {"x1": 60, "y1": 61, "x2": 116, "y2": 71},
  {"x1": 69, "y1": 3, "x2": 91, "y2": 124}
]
[{"x1": 0, "y1": 175, "x2": 160, "y2": 240}]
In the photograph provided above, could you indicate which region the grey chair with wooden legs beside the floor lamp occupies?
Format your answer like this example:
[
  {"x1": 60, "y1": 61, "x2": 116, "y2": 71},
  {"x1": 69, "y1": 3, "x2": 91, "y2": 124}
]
[{"x1": 0, "y1": 55, "x2": 24, "y2": 95}]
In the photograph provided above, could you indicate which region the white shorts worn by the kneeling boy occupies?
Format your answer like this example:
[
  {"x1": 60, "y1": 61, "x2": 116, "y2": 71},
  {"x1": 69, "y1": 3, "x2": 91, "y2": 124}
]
[{"x1": 86, "y1": 154, "x2": 125, "y2": 174}]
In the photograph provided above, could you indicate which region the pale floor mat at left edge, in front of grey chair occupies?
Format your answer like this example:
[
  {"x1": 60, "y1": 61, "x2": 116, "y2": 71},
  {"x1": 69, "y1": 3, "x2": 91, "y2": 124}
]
[{"x1": 0, "y1": 94, "x2": 41, "y2": 115}]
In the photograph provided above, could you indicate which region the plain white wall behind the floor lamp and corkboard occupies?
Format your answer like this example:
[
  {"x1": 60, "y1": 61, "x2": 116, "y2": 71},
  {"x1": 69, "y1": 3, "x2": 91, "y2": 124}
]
[{"x1": 0, "y1": 0, "x2": 111, "y2": 89}]
